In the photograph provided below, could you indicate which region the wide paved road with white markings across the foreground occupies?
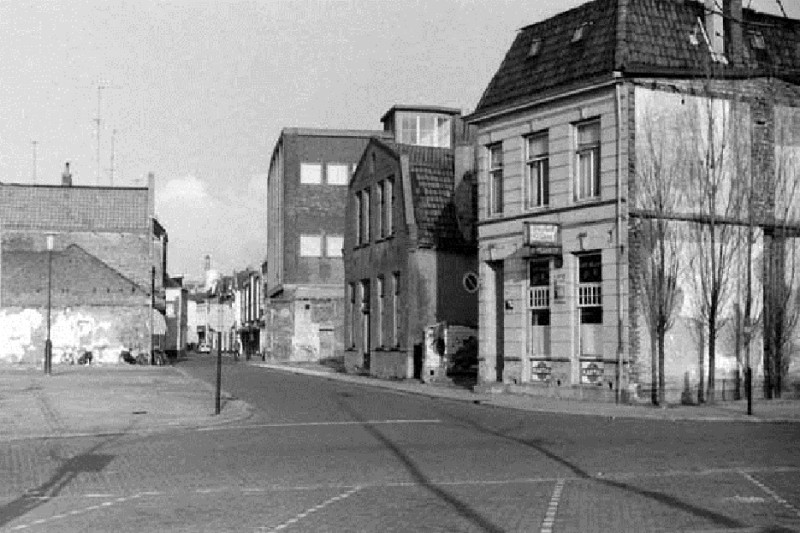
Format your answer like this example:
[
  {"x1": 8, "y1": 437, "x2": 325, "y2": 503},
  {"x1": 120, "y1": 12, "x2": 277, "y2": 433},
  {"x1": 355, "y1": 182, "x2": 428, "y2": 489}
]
[{"x1": 0, "y1": 356, "x2": 800, "y2": 532}]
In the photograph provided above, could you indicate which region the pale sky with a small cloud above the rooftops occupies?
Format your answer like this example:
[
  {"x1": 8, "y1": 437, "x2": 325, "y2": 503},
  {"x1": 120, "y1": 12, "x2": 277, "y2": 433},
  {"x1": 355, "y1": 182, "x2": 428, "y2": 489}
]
[{"x1": 0, "y1": 0, "x2": 800, "y2": 280}]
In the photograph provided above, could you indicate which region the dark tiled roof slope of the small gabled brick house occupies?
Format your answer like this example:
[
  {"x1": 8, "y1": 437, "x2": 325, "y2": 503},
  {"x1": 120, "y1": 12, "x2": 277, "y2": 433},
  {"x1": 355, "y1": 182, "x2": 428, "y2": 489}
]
[{"x1": 372, "y1": 139, "x2": 474, "y2": 250}]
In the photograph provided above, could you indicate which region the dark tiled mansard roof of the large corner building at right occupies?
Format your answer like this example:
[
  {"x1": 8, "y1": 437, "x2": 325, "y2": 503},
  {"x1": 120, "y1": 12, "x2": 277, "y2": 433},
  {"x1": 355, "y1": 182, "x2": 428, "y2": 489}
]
[{"x1": 472, "y1": 0, "x2": 800, "y2": 118}]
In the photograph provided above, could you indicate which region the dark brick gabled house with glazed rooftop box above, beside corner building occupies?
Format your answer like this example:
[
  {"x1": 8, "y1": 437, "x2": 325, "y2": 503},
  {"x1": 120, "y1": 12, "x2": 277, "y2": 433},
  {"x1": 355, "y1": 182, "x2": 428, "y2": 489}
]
[{"x1": 344, "y1": 106, "x2": 477, "y2": 378}]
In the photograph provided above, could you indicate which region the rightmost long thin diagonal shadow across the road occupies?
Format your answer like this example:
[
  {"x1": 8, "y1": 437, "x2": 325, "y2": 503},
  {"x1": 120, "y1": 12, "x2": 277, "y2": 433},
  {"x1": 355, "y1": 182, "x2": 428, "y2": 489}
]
[{"x1": 437, "y1": 409, "x2": 747, "y2": 529}]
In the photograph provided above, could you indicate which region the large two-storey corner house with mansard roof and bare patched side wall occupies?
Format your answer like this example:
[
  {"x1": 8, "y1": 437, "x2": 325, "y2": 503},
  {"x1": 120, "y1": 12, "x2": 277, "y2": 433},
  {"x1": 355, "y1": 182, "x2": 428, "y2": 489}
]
[{"x1": 466, "y1": 0, "x2": 800, "y2": 400}]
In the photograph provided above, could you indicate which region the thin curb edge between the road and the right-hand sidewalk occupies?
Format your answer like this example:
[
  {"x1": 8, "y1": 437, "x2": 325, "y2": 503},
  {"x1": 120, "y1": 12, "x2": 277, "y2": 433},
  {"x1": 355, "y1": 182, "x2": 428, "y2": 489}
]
[{"x1": 251, "y1": 363, "x2": 800, "y2": 424}]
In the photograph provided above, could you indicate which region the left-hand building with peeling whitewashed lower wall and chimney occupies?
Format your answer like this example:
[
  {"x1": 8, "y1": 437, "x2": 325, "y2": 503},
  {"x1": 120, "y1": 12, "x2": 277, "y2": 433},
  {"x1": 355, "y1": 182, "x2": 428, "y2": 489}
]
[{"x1": 0, "y1": 167, "x2": 167, "y2": 364}]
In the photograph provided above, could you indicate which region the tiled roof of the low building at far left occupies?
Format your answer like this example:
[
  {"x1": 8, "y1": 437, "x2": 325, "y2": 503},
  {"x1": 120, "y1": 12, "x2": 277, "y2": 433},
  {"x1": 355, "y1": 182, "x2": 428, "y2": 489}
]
[{"x1": 0, "y1": 183, "x2": 150, "y2": 232}]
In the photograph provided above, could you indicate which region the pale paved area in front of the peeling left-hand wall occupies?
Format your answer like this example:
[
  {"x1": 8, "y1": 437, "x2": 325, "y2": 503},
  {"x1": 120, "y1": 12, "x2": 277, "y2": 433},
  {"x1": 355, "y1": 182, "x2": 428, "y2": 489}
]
[{"x1": 0, "y1": 365, "x2": 250, "y2": 442}]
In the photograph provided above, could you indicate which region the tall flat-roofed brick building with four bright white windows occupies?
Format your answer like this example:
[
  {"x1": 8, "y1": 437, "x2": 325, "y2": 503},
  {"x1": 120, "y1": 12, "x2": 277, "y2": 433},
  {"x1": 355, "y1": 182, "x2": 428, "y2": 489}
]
[{"x1": 261, "y1": 128, "x2": 383, "y2": 361}]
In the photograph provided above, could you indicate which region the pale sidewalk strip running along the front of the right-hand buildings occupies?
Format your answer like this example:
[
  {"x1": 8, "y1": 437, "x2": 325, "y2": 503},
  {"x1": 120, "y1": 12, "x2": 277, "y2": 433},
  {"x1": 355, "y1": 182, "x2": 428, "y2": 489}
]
[{"x1": 255, "y1": 362, "x2": 800, "y2": 423}]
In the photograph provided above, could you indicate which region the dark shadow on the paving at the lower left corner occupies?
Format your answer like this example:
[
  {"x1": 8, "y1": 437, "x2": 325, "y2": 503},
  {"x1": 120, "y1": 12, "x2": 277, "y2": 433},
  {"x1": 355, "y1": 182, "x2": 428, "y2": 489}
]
[{"x1": 0, "y1": 425, "x2": 133, "y2": 528}]
